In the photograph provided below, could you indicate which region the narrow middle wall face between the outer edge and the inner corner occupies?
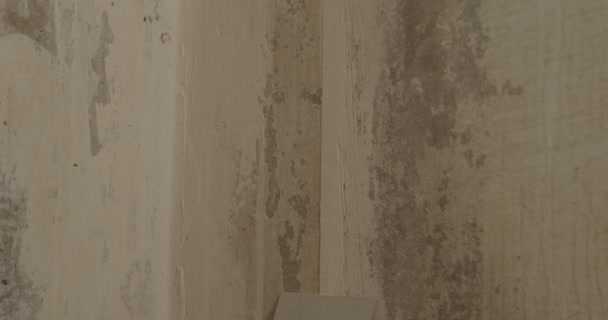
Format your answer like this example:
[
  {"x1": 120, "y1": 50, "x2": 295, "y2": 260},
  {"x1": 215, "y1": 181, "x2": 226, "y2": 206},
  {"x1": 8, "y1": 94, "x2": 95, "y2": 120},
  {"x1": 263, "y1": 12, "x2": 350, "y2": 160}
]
[{"x1": 175, "y1": 1, "x2": 321, "y2": 319}]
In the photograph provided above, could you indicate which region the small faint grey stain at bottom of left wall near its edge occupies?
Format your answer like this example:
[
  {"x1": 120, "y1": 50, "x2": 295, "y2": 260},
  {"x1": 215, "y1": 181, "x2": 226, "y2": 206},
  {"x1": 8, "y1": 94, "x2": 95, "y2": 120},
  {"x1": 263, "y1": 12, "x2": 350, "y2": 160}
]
[{"x1": 120, "y1": 260, "x2": 153, "y2": 319}]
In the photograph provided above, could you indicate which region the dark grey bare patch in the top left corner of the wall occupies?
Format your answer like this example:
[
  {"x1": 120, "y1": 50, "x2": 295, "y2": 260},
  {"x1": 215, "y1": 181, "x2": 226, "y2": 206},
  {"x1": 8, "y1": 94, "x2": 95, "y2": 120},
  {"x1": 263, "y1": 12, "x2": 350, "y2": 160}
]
[{"x1": 0, "y1": 0, "x2": 57, "y2": 54}]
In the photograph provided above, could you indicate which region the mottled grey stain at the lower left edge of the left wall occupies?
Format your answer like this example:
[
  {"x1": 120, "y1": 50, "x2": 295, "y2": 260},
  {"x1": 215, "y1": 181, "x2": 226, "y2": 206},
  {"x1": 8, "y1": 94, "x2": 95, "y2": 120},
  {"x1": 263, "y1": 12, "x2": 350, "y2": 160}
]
[{"x1": 0, "y1": 174, "x2": 43, "y2": 319}]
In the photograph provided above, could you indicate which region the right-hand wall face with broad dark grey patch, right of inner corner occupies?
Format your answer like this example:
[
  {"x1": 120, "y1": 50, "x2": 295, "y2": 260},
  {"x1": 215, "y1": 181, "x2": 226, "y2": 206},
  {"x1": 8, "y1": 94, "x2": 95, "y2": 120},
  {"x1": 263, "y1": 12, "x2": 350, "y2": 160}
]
[{"x1": 320, "y1": 0, "x2": 608, "y2": 320}]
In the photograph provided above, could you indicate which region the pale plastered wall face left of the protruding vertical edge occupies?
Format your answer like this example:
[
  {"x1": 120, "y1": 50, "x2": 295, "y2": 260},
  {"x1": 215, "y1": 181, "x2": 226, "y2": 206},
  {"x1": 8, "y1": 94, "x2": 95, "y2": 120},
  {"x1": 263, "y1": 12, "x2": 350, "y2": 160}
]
[{"x1": 0, "y1": 0, "x2": 177, "y2": 320}]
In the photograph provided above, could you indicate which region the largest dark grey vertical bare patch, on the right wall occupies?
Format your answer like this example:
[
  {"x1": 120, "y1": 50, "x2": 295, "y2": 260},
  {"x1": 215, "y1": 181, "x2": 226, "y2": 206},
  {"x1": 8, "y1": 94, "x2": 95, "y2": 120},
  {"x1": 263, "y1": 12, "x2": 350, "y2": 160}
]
[{"x1": 369, "y1": 0, "x2": 496, "y2": 320}]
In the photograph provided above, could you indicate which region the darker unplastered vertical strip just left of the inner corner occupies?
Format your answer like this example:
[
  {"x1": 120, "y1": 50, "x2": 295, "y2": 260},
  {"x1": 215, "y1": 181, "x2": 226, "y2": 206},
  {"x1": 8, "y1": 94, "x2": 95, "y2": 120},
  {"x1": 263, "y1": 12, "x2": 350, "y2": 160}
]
[{"x1": 260, "y1": 0, "x2": 322, "y2": 318}]
